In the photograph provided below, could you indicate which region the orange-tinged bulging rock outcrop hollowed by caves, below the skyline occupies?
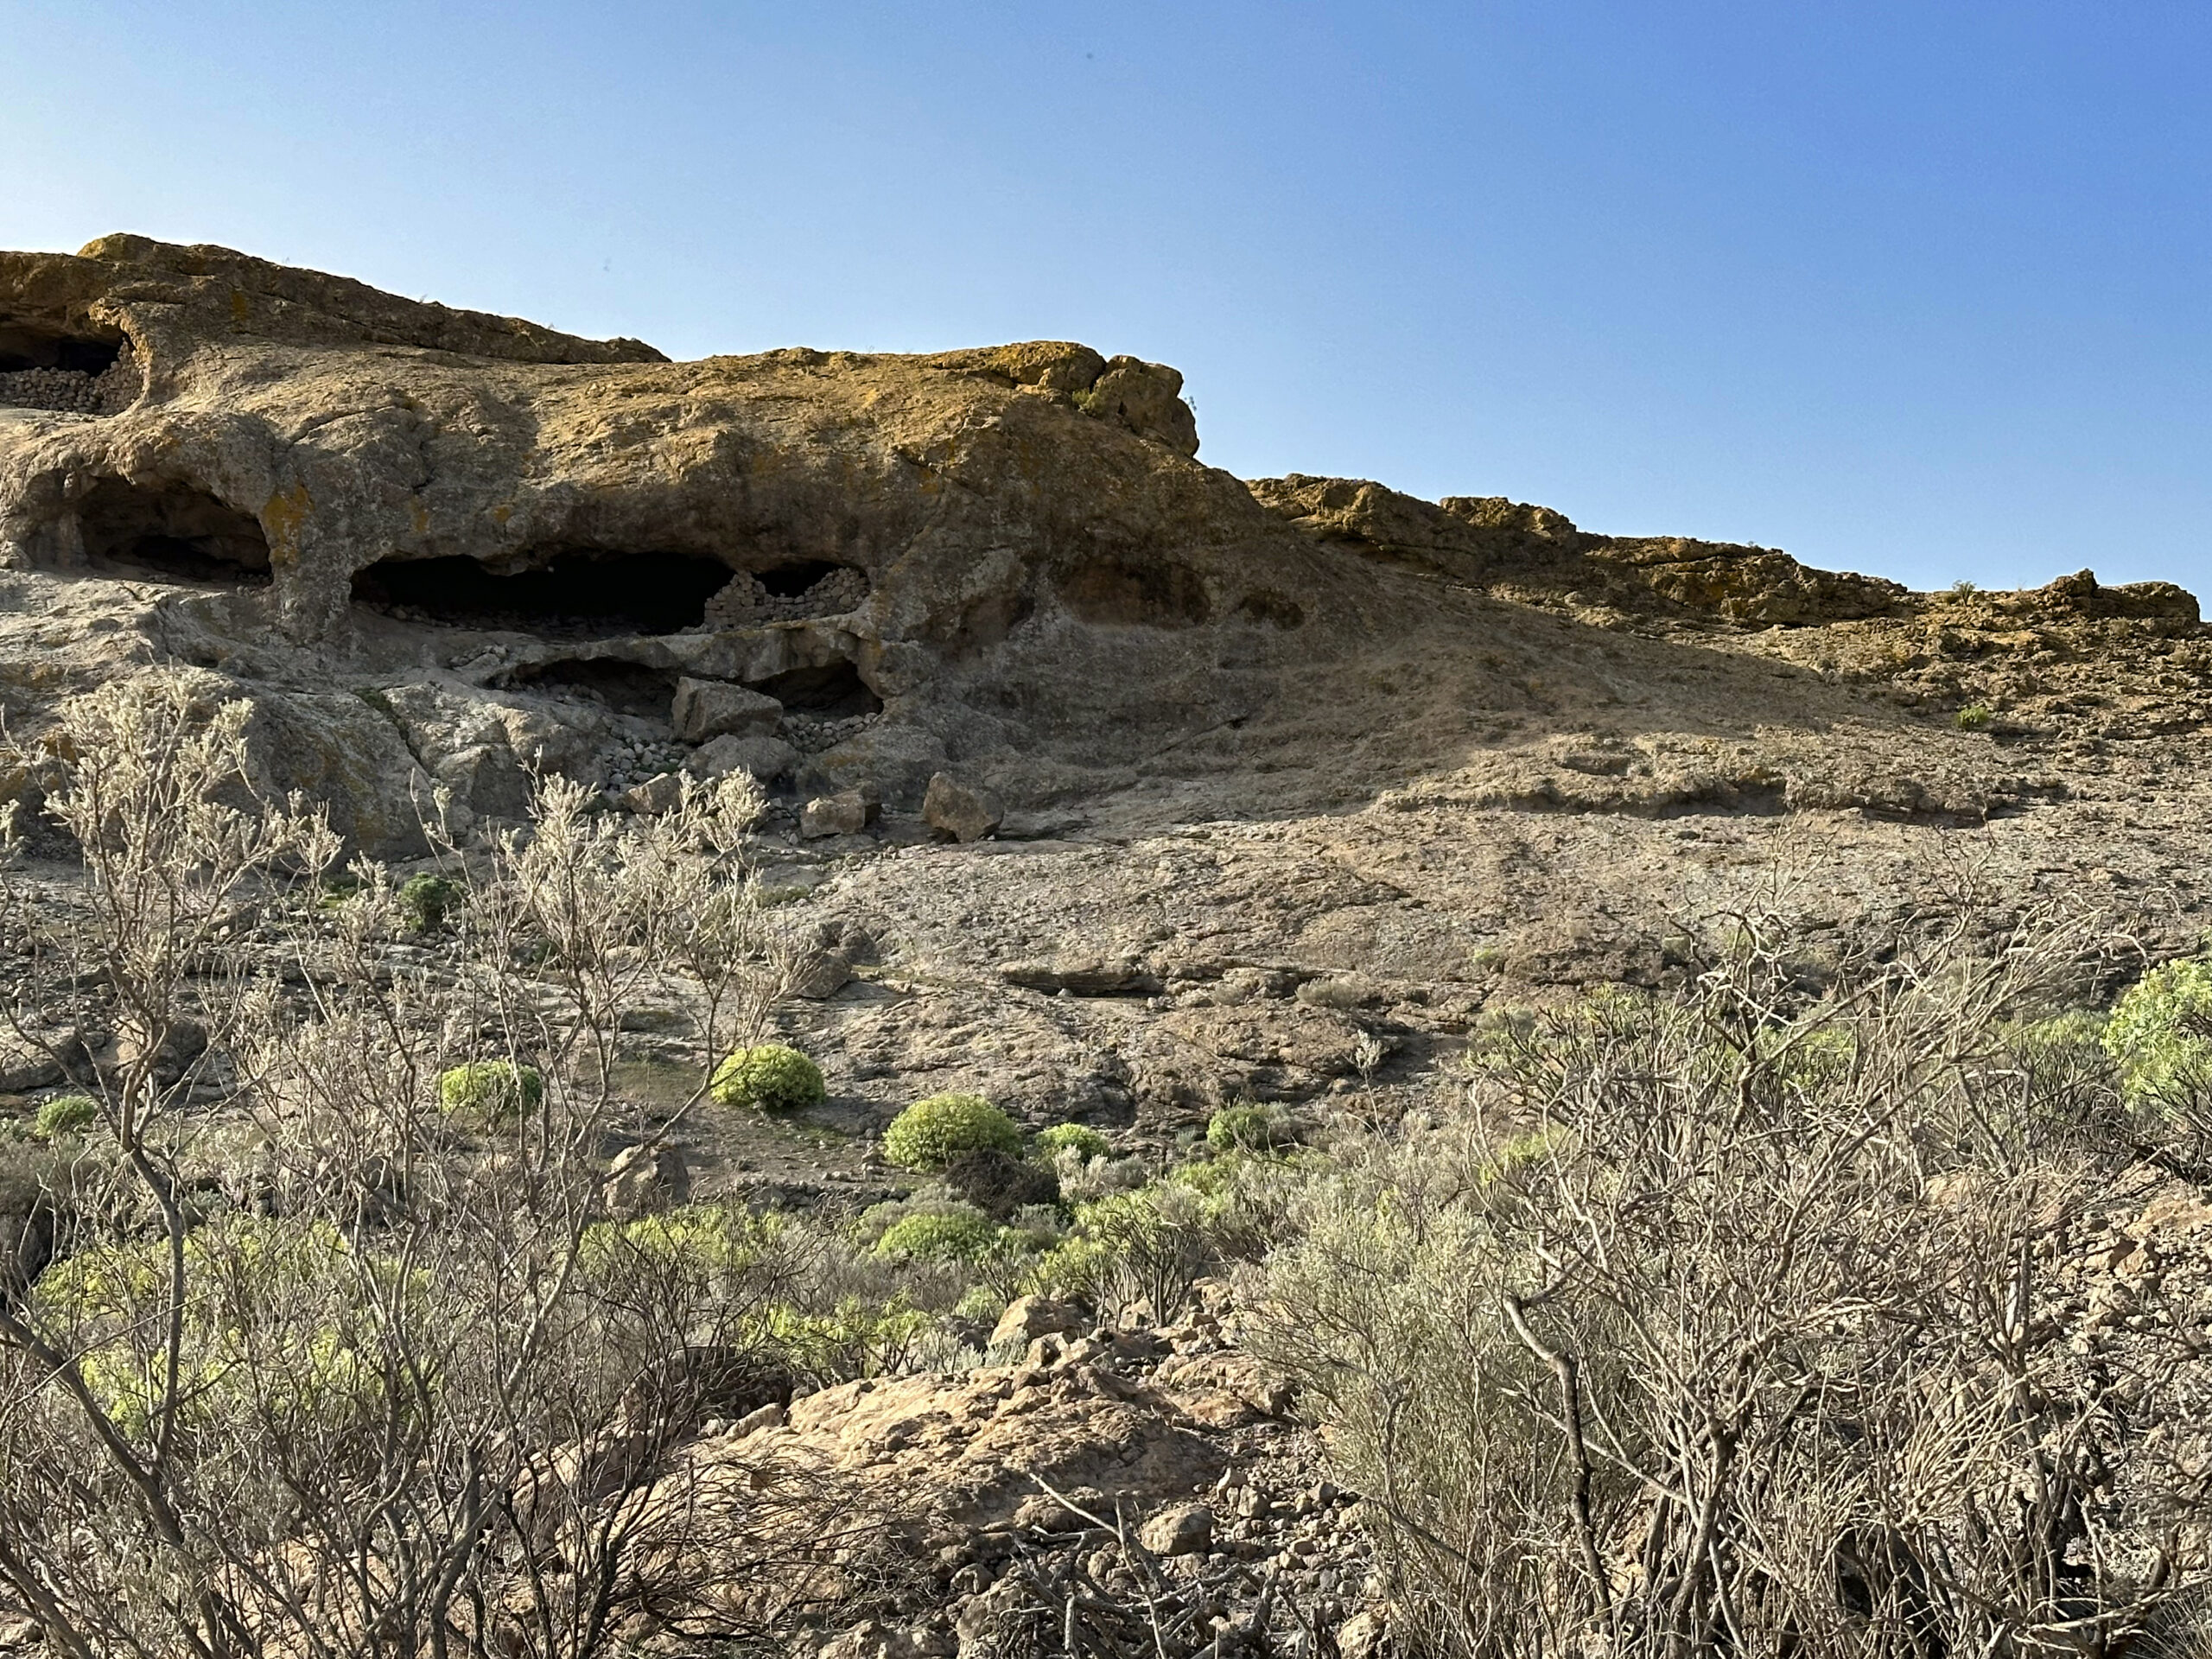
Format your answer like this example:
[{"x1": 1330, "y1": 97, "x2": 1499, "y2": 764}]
[{"x1": 0, "y1": 237, "x2": 1292, "y2": 852}]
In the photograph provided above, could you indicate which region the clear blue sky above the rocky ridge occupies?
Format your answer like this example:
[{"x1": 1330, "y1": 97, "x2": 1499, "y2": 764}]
[{"x1": 0, "y1": 0, "x2": 2212, "y2": 586}]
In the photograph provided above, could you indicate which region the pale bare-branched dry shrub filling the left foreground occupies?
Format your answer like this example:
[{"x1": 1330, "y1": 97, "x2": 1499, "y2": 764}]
[{"x1": 0, "y1": 677, "x2": 869, "y2": 1659}]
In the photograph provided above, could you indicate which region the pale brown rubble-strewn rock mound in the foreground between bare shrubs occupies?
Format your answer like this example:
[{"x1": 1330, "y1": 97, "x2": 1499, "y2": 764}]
[{"x1": 606, "y1": 1281, "x2": 1385, "y2": 1655}]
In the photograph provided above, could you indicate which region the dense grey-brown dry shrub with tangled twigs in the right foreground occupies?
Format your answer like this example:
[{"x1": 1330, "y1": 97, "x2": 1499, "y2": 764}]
[{"x1": 1263, "y1": 898, "x2": 2212, "y2": 1659}]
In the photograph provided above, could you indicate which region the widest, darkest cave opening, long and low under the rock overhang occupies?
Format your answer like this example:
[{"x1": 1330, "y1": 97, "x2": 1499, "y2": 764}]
[{"x1": 354, "y1": 550, "x2": 730, "y2": 639}]
